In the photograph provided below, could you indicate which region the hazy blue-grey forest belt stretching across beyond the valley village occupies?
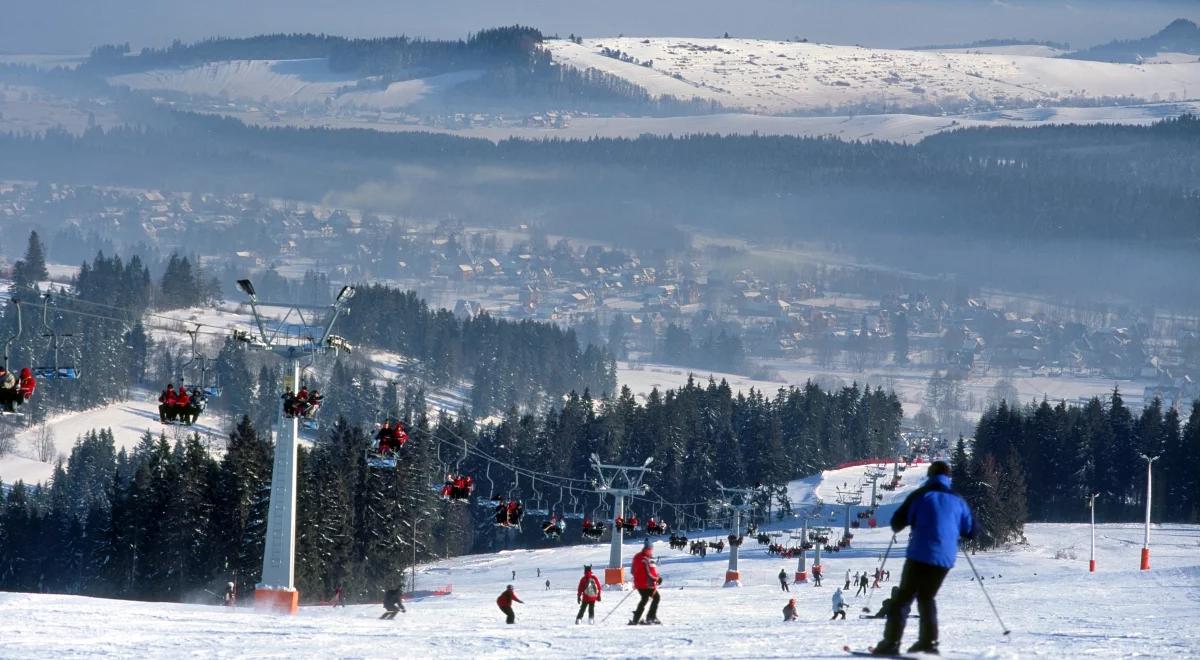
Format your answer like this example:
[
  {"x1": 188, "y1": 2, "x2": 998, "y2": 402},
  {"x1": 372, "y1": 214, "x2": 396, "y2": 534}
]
[{"x1": 0, "y1": 113, "x2": 1200, "y2": 250}]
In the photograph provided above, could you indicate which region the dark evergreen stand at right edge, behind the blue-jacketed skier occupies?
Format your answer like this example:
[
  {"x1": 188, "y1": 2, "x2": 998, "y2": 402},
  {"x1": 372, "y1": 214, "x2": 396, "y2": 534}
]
[{"x1": 953, "y1": 390, "x2": 1200, "y2": 547}]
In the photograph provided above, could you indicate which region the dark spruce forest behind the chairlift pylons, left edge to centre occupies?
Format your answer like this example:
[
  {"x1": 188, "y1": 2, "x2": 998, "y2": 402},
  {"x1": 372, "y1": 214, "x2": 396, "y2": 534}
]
[{"x1": 0, "y1": 374, "x2": 900, "y2": 601}]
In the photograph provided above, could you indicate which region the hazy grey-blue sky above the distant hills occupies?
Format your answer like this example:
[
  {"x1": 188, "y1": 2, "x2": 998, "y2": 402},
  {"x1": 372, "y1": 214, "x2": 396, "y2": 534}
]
[{"x1": 0, "y1": 0, "x2": 1200, "y2": 53}]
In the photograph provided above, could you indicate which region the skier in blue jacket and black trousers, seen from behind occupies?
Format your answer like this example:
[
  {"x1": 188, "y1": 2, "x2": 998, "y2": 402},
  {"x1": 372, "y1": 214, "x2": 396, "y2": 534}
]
[{"x1": 872, "y1": 461, "x2": 976, "y2": 655}]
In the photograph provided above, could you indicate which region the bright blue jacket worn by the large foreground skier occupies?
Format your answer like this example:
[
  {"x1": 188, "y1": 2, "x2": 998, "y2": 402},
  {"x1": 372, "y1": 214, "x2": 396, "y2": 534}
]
[{"x1": 892, "y1": 474, "x2": 976, "y2": 569}]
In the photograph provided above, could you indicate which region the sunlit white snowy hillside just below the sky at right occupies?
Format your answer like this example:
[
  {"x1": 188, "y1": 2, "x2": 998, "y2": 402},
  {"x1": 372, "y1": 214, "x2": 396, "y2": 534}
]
[{"x1": 545, "y1": 37, "x2": 1200, "y2": 114}]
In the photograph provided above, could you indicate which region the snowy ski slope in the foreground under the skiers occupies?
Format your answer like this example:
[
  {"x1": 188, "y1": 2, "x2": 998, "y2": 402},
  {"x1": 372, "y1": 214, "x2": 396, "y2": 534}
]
[{"x1": 0, "y1": 463, "x2": 1200, "y2": 658}]
